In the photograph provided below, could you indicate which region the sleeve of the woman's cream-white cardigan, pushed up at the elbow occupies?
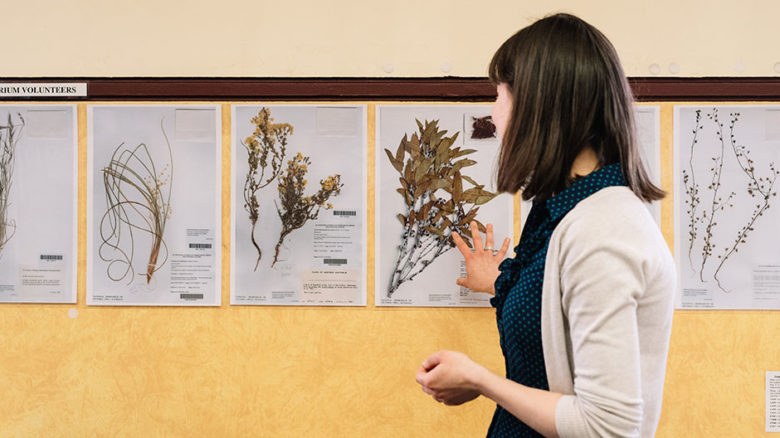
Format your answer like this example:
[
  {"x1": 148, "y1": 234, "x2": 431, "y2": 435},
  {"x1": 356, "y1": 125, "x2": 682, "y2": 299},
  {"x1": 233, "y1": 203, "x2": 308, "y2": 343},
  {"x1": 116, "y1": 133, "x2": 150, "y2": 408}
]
[{"x1": 555, "y1": 213, "x2": 652, "y2": 438}]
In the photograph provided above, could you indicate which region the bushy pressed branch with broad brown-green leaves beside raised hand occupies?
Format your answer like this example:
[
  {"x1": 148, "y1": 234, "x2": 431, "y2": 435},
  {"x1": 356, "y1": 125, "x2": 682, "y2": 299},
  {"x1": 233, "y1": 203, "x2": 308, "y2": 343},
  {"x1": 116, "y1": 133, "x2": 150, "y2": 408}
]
[{"x1": 385, "y1": 120, "x2": 496, "y2": 298}]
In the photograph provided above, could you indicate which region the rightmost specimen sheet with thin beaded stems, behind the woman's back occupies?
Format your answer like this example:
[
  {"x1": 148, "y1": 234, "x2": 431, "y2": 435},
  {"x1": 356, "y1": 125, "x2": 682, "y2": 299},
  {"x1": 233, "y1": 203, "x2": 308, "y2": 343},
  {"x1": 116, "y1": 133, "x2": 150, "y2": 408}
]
[{"x1": 674, "y1": 105, "x2": 780, "y2": 309}]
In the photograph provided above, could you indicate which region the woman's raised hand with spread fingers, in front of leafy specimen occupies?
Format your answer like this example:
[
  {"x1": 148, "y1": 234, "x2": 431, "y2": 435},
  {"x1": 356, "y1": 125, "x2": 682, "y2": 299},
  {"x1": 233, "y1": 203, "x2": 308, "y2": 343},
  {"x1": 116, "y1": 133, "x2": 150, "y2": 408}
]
[{"x1": 452, "y1": 222, "x2": 510, "y2": 294}]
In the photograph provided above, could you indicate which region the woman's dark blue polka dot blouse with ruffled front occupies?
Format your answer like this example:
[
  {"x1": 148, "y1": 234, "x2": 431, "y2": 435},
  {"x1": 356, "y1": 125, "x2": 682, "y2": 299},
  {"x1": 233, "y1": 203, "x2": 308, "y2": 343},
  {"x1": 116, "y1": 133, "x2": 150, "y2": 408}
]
[{"x1": 488, "y1": 163, "x2": 626, "y2": 438}]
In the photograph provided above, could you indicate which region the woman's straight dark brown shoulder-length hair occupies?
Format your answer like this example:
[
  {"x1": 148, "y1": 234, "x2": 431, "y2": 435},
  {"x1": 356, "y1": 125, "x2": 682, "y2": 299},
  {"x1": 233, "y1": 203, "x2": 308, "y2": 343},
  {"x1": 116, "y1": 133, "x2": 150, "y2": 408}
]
[{"x1": 489, "y1": 14, "x2": 664, "y2": 201}]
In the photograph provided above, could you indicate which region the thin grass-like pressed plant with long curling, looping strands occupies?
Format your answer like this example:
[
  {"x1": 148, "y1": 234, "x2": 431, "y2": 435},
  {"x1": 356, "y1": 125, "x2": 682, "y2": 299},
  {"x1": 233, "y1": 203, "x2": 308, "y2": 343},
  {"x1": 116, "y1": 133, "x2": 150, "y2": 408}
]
[{"x1": 99, "y1": 119, "x2": 173, "y2": 284}]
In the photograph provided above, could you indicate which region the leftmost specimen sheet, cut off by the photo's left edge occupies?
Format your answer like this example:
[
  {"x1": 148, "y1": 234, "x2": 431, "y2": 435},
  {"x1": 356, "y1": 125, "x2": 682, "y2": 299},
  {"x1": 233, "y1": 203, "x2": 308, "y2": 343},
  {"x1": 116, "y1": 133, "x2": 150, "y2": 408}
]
[{"x1": 0, "y1": 104, "x2": 77, "y2": 303}]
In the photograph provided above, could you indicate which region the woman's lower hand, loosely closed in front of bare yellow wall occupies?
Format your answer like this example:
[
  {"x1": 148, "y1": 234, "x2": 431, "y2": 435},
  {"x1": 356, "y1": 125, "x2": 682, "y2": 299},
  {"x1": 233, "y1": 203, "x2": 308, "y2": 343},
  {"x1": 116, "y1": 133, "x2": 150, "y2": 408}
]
[{"x1": 415, "y1": 351, "x2": 488, "y2": 405}]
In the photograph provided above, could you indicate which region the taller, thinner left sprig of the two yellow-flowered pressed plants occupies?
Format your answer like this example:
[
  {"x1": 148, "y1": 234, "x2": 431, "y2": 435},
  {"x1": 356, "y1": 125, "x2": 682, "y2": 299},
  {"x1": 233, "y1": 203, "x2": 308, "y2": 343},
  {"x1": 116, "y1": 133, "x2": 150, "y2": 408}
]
[{"x1": 242, "y1": 107, "x2": 293, "y2": 271}]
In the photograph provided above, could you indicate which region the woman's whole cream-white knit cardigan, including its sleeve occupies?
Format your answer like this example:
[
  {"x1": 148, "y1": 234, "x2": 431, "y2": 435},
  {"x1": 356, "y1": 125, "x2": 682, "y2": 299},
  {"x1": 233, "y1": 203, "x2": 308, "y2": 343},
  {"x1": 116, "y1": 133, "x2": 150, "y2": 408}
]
[{"x1": 542, "y1": 187, "x2": 676, "y2": 438}]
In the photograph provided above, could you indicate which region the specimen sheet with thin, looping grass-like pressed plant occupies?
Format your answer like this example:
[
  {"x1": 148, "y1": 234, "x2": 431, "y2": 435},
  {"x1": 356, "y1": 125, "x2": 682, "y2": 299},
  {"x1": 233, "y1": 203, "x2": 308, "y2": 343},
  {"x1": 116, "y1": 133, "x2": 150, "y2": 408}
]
[{"x1": 87, "y1": 105, "x2": 222, "y2": 306}]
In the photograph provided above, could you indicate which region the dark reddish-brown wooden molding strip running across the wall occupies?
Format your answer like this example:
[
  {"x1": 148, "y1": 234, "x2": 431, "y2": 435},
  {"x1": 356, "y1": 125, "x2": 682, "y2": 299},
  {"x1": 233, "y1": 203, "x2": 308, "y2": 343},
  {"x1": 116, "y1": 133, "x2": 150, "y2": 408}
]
[{"x1": 0, "y1": 77, "x2": 780, "y2": 101}]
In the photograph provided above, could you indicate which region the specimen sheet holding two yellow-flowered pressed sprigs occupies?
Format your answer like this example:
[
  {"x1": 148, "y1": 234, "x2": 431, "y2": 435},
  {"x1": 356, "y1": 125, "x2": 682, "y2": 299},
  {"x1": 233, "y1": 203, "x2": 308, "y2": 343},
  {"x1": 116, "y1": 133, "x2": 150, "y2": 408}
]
[{"x1": 230, "y1": 105, "x2": 367, "y2": 306}]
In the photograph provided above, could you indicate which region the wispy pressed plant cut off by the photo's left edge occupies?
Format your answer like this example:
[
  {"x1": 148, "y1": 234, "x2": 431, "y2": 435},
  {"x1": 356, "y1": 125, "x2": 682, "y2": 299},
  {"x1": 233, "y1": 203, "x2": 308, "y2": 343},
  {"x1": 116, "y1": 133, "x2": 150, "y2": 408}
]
[{"x1": 0, "y1": 113, "x2": 24, "y2": 254}]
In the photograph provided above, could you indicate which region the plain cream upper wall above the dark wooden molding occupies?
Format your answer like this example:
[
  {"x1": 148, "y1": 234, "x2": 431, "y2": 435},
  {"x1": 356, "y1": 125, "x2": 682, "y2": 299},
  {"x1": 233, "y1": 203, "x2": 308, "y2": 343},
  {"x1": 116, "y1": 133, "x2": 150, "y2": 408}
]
[{"x1": 6, "y1": 0, "x2": 780, "y2": 77}]
